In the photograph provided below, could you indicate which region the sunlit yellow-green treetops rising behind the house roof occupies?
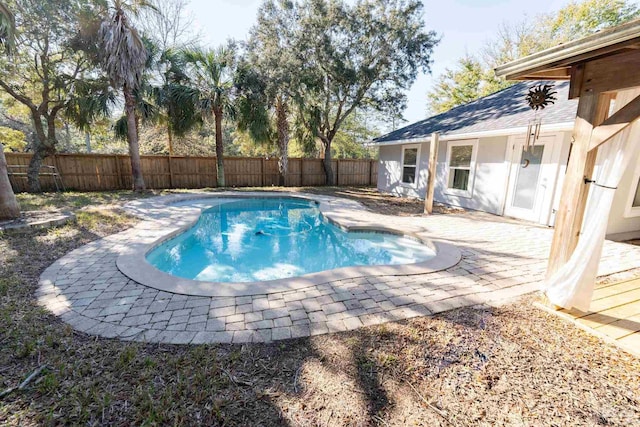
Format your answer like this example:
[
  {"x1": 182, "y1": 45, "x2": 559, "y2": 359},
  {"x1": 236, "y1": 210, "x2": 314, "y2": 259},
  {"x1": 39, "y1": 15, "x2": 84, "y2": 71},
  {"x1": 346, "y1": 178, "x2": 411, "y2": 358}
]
[{"x1": 427, "y1": 0, "x2": 640, "y2": 113}]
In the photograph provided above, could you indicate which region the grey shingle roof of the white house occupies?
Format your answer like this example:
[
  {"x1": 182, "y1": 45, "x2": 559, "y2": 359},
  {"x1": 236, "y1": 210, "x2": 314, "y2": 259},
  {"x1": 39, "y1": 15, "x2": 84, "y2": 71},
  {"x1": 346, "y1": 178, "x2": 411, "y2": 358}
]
[{"x1": 373, "y1": 81, "x2": 578, "y2": 144}]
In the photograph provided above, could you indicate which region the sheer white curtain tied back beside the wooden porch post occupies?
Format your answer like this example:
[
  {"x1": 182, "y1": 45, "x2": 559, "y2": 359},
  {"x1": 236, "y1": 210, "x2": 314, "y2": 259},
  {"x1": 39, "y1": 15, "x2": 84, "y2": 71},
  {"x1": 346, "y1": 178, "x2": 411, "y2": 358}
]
[{"x1": 544, "y1": 89, "x2": 640, "y2": 311}]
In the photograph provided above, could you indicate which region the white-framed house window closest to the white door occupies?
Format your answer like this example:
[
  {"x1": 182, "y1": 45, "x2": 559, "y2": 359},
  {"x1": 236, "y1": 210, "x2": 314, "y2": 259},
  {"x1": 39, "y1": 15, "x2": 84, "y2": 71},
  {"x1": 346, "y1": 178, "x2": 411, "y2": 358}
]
[{"x1": 447, "y1": 140, "x2": 478, "y2": 197}]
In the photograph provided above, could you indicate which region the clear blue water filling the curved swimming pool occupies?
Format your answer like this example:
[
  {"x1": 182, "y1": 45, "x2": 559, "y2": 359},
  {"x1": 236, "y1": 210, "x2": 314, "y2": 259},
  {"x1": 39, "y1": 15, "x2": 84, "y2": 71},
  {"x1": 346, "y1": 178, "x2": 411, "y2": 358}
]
[{"x1": 147, "y1": 198, "x2": 435, "y2": 282}]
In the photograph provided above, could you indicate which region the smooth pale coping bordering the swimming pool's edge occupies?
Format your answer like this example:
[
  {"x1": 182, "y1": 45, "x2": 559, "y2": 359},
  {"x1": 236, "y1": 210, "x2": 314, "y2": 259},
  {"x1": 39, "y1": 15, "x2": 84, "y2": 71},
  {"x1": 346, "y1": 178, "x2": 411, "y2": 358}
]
[{"x1": 116, "y1": 192, "x2": 462, "y2": 297}]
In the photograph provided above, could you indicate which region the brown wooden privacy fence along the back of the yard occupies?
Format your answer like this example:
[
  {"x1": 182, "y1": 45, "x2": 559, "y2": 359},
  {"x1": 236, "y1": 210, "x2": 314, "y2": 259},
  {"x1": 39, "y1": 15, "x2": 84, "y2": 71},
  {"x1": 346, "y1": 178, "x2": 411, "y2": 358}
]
[{"x1": 5, "y1": 153, "x2": 378, "y2": 192}]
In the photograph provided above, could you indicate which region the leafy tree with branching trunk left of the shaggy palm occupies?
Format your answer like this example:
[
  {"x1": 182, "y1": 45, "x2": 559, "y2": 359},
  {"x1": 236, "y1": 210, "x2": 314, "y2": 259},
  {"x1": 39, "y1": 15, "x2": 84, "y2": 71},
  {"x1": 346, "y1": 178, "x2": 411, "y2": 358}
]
[{"x1": 0, "y1": 0, "x2": 100, "y2": 152}]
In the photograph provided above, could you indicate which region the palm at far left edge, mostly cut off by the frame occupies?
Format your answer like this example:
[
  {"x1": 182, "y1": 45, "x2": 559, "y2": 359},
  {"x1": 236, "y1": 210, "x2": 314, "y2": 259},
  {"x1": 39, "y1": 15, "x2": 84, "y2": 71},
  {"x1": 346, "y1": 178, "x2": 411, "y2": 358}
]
[{"x1": 0, "y1": 3, "x2": 20, "y2": 220}]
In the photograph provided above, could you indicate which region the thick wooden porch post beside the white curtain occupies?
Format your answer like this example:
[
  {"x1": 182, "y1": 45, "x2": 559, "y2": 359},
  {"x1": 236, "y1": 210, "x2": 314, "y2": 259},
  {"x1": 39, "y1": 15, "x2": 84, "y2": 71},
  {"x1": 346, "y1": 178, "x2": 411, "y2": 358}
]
[{"x1": 547, "y1": 92, "x2": 612, "y2": 277}]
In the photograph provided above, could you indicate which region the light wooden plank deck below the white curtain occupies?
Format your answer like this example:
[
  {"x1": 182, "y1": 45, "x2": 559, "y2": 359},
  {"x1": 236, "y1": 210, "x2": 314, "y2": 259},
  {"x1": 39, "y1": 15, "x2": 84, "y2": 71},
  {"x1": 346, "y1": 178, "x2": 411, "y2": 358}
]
[{"x1": 544, "y1": 278, "x2": 640, "y2": 357}]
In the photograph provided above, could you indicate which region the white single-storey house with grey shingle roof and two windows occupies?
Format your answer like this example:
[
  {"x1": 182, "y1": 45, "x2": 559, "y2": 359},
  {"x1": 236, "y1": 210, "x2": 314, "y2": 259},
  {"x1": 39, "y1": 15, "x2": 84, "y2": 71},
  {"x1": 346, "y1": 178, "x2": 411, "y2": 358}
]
[{"x1": 374, "y1": 81, "x2": 640, "y2": 240}]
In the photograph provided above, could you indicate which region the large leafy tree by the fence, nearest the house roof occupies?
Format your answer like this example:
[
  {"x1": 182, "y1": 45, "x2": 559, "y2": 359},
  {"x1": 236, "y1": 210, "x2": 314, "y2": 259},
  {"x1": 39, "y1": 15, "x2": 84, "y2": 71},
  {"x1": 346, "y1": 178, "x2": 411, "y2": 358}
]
[{"x1": 281, "y1": 0, "x2": 437, "y2": 181}]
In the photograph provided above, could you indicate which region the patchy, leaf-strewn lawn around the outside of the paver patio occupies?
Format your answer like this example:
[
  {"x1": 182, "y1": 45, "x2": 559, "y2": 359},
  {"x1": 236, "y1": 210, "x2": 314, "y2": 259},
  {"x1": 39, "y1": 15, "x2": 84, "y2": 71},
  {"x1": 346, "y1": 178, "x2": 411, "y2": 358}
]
[{"x1": 0, "y1": 188, "x2": 640, "y2": 426}]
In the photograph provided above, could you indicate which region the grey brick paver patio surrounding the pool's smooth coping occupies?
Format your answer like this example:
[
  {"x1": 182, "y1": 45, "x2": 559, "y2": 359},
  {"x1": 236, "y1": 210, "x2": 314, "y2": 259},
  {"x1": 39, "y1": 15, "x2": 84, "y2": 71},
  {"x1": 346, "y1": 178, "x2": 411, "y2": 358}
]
[{"x1": 38, "y1": 192, "x2": 640, "y2": 344}]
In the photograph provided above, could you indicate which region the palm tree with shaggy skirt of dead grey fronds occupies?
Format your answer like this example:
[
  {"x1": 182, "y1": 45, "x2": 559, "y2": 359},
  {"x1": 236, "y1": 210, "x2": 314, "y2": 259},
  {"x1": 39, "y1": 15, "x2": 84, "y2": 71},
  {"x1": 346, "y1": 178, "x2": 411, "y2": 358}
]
[{"x1": 98, "y1": 0, "x2": 152, "y2": 191}]
